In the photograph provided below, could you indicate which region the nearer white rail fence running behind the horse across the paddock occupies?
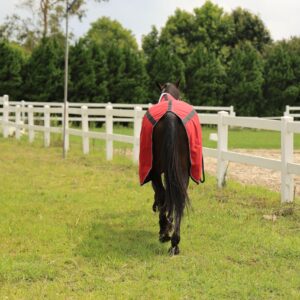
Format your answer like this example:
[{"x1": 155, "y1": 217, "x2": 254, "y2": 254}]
[{"x1": 0, "y1": 97, "x2": 300, "y2": 202}]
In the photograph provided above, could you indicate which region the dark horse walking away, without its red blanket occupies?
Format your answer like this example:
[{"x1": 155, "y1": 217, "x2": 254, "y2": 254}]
[{"x1": 150, "y1": 82, "x2": 190, "y2": 255}]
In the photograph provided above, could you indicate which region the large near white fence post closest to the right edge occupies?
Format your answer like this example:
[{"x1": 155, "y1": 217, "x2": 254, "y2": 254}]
[{"x1": 281, "y1": 116, "x2": 294, "y2": 203}]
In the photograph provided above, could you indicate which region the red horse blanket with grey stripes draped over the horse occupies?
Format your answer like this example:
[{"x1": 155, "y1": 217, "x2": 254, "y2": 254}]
[{"x1": 139, "y1": 94, "x2": 203, "y2": 185}]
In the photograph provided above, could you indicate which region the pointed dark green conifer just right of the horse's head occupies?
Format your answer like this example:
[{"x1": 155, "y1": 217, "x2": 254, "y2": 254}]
[{"x1": 186, "y1": 44, "x2": 226, "y2": 105}]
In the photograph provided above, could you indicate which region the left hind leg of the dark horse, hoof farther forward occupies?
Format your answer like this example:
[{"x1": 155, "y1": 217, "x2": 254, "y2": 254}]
[{"x1": 152, "y1": 175, "x2": 173, "y2": 243}]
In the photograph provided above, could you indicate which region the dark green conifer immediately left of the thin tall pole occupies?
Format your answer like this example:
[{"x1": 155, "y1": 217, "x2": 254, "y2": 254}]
[{"x1": 23, "y1": 37, "x2": 64, "y2": 102}]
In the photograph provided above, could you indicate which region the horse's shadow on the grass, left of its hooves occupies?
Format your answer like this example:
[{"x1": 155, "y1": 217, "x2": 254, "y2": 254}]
[{"x1": 76, "y1": 211, "x2": 168, "y2": 261}]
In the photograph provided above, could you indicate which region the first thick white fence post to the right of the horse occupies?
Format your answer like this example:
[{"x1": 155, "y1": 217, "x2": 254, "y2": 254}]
[{"x1": 217, "y1": 111, "x2": 228, "y2": 188}]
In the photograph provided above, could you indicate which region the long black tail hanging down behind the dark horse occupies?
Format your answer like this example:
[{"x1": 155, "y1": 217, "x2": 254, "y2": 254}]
[{"x1": 163, "y1": 112, "x2": 189, "y2": 218}]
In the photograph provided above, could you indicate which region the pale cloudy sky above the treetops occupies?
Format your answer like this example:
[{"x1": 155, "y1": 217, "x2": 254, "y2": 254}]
[{"x1": 0, "y1": 0, "x2": 300, "y2": 44}]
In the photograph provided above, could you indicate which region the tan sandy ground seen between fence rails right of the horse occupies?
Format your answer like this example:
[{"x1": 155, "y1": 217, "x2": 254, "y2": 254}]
[{"x1": 204, "y1": 149, "x2": 300, "y2": 195}]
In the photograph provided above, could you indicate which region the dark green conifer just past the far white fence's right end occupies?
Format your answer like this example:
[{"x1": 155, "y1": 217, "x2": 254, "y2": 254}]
[{"x1": 227, "y1": 42, "x2": 264, "y2": 116}]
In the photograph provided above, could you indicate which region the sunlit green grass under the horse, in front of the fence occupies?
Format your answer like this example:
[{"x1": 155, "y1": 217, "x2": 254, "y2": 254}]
[{"x1": 0, "y1": 137, "x2": 300, "y2": 299}]
